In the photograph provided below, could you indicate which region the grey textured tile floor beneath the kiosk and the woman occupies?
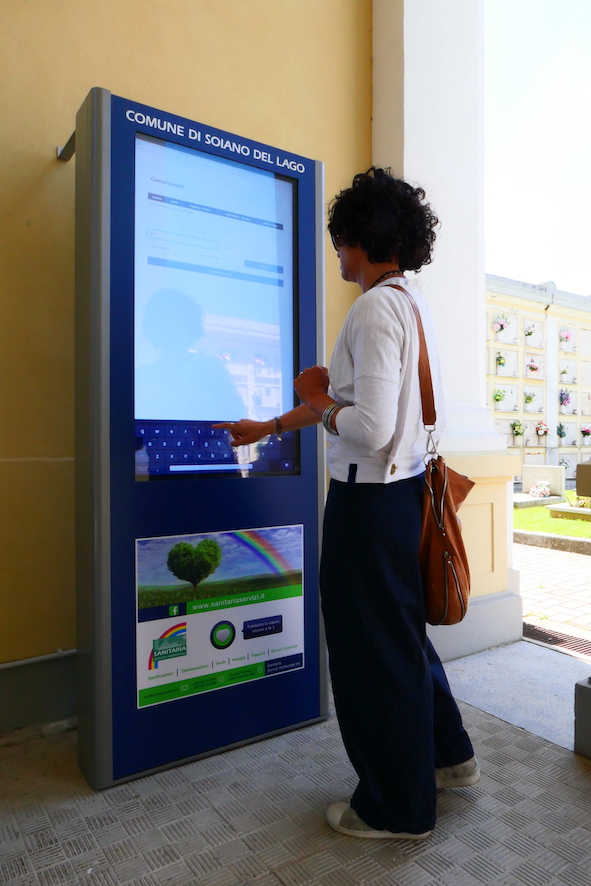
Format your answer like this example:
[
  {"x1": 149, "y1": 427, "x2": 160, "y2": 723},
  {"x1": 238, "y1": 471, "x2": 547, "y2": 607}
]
[{"x1": 0, "y1": 705, "x2": 591, "y2": 886}]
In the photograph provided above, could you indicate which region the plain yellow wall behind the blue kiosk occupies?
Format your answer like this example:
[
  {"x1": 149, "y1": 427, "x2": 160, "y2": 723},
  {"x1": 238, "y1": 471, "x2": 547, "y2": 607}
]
[{"x1": 0, "y1": 0, "x2": 372, "y2": 661}]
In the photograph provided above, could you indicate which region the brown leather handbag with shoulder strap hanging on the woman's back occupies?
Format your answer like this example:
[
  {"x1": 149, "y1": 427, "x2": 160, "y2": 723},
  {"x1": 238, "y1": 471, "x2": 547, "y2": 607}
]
[{"x1": 389, "y1": 284, "x2": 474, "y2": 625}]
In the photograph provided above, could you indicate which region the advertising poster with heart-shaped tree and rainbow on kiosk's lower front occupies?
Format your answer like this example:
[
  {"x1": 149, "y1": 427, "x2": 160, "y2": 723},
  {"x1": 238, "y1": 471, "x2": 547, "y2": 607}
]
[{"x1": 136, "y1": 525, "x2": 304, "y2": 708}]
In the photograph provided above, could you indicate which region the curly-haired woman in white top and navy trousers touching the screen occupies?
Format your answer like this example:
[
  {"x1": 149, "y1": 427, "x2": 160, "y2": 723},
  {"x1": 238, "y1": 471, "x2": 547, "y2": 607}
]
[{"x1": 216, "y1": 167, "x2": 480, "y2": 840}]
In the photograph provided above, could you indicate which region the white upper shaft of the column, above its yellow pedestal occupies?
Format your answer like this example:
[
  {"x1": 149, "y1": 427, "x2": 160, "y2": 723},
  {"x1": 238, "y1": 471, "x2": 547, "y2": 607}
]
[{"x1": 373, "y1": 0, "x2": 506, "y2": 452}]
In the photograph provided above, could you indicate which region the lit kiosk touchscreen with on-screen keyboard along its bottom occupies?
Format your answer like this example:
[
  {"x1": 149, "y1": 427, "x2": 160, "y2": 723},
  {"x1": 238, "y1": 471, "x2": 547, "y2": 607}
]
[{"x1": 134, "y1": 133, "x2": 299, "y2": 479}]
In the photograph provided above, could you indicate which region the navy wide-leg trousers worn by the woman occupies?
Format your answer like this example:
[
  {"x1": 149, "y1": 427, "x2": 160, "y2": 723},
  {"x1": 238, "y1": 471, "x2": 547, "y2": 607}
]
[{"x1": 320, "y1": 475, "x2": 474, "y2": 834}]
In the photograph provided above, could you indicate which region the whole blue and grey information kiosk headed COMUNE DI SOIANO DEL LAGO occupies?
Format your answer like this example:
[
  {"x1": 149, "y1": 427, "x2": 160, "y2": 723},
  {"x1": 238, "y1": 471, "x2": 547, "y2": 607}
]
[{"x1": 75, "y1": 89, "x2": 327, "y2": 788}]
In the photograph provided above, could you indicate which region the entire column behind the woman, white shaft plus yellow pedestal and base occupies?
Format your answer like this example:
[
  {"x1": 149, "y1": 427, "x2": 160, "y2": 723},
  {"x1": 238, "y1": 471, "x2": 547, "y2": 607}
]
[{"x1": 373, "y1": 0, "x2": 522, "y2": 659}]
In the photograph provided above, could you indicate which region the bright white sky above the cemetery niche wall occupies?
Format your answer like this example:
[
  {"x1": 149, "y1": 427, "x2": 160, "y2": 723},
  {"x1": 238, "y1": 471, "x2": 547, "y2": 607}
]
[{"x1": 485, "y1": 0, "x2": 591, "y2": 295}]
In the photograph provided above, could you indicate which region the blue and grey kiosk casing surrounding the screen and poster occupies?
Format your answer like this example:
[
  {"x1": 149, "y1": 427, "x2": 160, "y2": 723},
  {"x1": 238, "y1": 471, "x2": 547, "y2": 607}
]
[{"x1": 73, "y1": 88, "x2": 328, "y2": 789}]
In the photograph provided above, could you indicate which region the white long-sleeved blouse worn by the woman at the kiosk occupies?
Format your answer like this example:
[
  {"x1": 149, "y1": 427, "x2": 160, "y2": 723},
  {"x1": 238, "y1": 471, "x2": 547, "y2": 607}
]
[{"x1": 328, "y1": 277, "x2": 444, "y2": 483}]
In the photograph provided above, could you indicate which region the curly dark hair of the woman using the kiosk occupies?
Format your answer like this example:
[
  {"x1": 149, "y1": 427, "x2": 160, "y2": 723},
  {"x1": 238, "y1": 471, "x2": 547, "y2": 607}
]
[{"x1": 328, "y1": 166, "x2": 439, "y2": 271}]
